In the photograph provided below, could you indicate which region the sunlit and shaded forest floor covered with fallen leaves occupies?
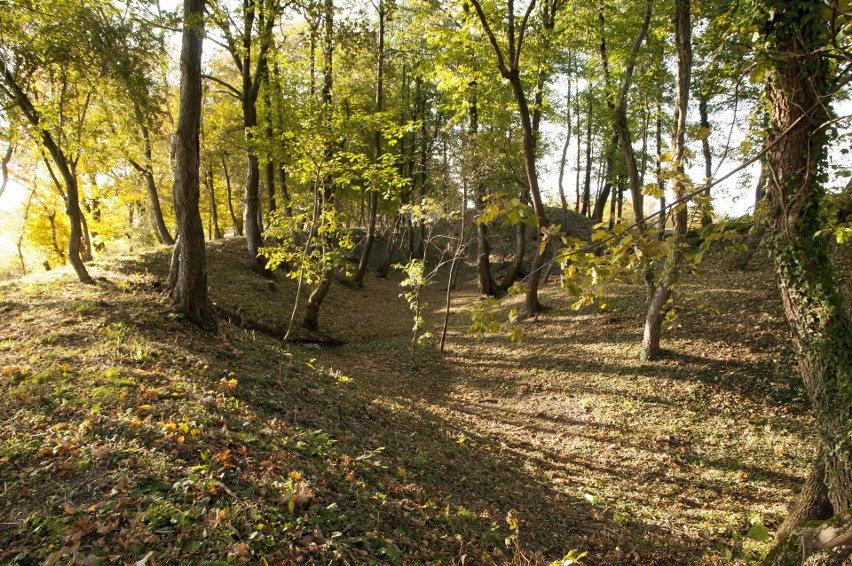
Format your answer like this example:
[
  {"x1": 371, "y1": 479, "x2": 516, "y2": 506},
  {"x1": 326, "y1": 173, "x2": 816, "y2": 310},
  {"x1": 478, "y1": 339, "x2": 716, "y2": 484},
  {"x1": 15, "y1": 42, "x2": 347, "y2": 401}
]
[{"x1": 0, "y1": 240, "x2": 814, "y2": 565}]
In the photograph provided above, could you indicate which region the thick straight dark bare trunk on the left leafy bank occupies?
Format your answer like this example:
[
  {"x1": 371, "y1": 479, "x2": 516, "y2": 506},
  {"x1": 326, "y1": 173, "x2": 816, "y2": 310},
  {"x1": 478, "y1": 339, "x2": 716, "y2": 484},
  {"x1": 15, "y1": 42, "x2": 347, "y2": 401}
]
[{"x1": 170, "y1": 0, "x2": 215, "y2": 328}]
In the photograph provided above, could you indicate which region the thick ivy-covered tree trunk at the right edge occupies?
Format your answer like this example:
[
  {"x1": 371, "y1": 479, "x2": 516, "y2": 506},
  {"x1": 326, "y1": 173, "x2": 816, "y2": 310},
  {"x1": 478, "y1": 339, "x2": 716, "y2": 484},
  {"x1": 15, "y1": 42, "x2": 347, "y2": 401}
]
[{"x1": 761, "y1": 1, "x2": 852, "y2": 544}]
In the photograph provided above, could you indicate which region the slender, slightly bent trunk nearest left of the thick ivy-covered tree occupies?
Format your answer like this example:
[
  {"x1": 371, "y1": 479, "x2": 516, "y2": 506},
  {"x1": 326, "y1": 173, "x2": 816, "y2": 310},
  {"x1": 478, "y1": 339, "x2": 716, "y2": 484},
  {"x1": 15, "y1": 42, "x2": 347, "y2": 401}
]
[{"x1": 641, "y1": 0, "x2": 692, "y2": 360}]
